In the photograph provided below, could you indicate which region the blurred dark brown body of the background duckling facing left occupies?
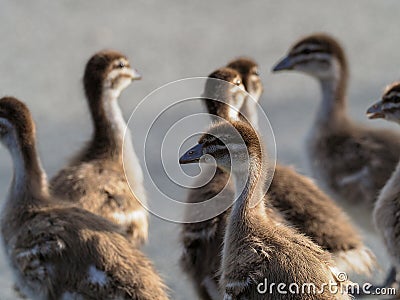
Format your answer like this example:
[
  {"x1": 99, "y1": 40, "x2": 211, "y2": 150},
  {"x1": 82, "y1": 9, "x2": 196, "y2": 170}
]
[{"x1": 310, "y1": 128, "x2": 400, "y2": 208}]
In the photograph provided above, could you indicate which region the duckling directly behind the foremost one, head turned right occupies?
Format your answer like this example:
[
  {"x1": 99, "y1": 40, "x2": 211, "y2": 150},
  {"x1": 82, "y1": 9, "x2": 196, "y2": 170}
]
[{"x1": 180, "y1": 68, "x2": 247, "y2": 300}]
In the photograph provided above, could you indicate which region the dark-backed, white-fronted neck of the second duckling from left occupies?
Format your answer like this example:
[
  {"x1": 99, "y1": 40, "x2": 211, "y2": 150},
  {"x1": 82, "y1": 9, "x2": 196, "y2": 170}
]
[{"x1": 88, "y1": 90, "x2": 129, "y2": 160}]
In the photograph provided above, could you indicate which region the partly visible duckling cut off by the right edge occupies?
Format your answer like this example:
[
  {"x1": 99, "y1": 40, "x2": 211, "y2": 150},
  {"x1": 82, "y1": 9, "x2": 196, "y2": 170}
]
[{"x1": 367, "y1": 82, "x2": 400, "y2": 288}]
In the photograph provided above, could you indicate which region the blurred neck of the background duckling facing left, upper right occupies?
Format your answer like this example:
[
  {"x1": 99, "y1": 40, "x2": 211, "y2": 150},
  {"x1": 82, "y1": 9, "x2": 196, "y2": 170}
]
[{"x1": 316, "y1": 67, "x2": 348, "y2": 126}]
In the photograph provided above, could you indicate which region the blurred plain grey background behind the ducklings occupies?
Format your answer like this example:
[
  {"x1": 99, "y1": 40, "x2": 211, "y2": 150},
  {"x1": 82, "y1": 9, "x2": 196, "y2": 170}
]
[{"x1": 0, "y1": 0, "x2": 400, "y2": 300}]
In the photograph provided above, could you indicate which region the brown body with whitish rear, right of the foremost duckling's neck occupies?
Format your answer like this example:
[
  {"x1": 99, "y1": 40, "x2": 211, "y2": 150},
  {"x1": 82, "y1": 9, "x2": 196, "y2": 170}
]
[{"x1": 268, "y1": 164, "x2": 376, "y2": 275}]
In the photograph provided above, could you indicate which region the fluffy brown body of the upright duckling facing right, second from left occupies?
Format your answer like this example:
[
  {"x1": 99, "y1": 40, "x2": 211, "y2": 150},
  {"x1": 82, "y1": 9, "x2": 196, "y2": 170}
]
[{"x1": 51, "y1": 163, "x2": 148, "y2": 244}]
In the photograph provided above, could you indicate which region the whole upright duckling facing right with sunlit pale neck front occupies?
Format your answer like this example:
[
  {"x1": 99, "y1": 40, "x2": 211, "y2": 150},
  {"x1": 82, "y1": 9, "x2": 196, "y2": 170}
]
[{"x1": 51, "y1": 51, "x2": 148, "y2": 245}]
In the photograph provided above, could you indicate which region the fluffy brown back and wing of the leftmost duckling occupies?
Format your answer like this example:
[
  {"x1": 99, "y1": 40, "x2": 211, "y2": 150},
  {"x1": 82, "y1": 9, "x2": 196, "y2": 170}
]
[{"x1": 12, "y1": 206, "x2": 167, "y2": 299}]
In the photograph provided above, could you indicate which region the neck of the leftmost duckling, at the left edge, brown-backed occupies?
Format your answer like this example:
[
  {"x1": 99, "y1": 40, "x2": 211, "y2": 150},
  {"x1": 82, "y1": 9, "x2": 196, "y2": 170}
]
[{"x1": 9, "y1": 135, "x2": 48, "y2": 205}]
